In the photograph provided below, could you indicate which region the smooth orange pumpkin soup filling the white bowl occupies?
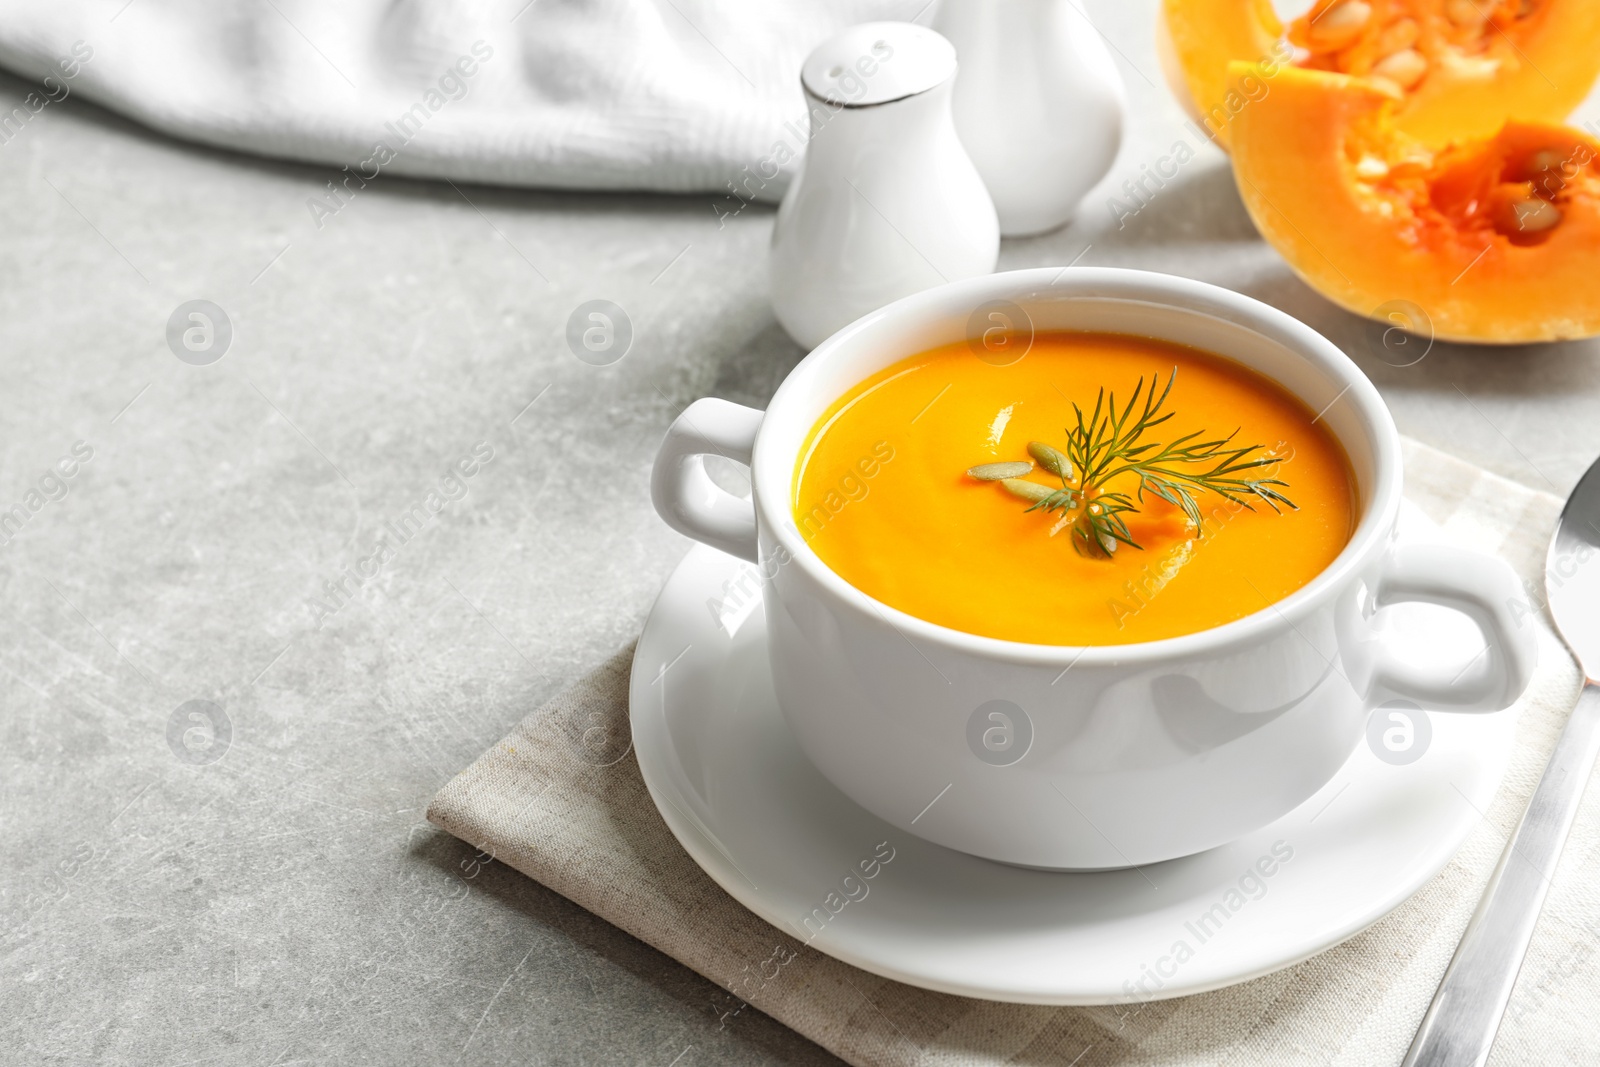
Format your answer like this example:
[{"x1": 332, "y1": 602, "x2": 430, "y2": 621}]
[{"x1": 792, "y1": 333, "x2": 1357, "y2": 645}]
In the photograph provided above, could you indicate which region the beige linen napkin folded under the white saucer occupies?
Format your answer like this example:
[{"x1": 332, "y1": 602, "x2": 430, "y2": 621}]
[{"x1": 427, "y1": 442, "x2": 1600, "y2": 1067}]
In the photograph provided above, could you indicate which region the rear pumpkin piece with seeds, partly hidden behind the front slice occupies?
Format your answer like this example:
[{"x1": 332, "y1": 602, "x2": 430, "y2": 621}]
[{"x1": 1158, "y1": 0, "x2": 1600, "y2": 147}]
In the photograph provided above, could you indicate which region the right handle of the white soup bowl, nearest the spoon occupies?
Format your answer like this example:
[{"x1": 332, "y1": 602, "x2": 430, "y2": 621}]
[{"x1": 1352, "y1": 542, "x2": 1539, "y2": 712}]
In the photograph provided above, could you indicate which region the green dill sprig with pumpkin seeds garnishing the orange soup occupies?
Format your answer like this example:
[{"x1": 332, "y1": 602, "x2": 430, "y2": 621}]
[{"x1": 971, "y1": 366, "x2": 1298, "y2": 557}]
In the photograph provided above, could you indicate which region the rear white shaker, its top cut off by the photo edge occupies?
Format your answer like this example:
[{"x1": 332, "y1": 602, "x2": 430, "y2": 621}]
[{"x1": 933, "y1": 0, "x2": 1126, "y2": 237}]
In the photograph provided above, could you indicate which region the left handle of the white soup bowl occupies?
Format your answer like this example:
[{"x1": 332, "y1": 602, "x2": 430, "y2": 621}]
[{"x1": 650, "y1": 397, "x2": 766, "y2": 563}]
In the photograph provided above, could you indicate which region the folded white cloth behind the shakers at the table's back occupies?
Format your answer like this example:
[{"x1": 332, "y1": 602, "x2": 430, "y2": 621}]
[{"x1": 0, "y1": 0, "x2": 930, "y2": 200}]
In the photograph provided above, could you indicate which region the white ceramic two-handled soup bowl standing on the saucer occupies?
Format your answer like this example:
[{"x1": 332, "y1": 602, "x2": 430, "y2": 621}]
[{"x1": 651, "y1": 267, "x2": 1536, "y2": 869}]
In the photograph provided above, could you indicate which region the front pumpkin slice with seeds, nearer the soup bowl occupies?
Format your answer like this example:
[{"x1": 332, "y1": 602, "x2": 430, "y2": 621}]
[{"x1": 1230, "y1": 64, "x2": 1600, "y2": 344}]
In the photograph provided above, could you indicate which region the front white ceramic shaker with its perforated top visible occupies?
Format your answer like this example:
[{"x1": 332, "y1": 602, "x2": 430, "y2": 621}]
[{"x1": 770, "y1": 22, "x2": 1000, "y2": 349}]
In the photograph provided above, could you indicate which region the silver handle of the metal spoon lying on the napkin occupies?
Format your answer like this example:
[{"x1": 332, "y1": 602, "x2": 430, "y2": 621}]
[{"x1": 1402, "y1": 683, "x2": 1600, "y2": 1067}]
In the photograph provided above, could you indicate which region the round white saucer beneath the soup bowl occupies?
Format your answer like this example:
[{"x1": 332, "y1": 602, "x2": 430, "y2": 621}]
[{"x1": 629, "y1": 512, "x2": 1515, "y2": 1005}]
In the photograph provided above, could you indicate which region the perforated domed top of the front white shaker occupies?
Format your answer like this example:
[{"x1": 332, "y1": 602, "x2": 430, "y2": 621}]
[{"x1": 800, "y1": 22, "x2": 955, "y2": 107}]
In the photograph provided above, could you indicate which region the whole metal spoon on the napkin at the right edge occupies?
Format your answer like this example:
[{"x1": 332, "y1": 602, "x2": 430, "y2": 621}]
[{"x1": 1402, "y1": 461, "x2": 1600, "y2": 1067}]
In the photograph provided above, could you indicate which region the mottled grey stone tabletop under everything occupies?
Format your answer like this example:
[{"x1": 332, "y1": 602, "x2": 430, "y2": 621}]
[{"x1": 9, "y1": 3, "x2": 1600, "y2": 1067}]
